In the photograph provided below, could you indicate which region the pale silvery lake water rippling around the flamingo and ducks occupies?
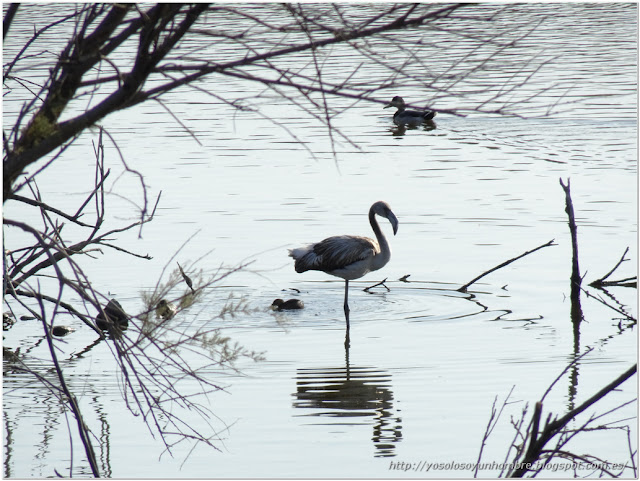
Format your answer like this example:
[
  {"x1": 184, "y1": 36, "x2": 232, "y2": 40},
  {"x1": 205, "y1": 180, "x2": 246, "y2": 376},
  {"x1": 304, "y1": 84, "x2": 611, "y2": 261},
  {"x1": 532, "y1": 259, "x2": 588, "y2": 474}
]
[{"x1": 3, "y1": 4, "x2": 637, "y2": 478}]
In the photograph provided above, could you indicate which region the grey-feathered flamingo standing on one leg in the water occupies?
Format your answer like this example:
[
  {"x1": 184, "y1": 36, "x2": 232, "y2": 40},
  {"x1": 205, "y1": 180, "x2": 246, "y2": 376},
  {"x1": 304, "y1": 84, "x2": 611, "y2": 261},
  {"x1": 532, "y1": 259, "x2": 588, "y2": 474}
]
[{"x1": 289, "y1": 201, "x2": 398, "y2": 346}]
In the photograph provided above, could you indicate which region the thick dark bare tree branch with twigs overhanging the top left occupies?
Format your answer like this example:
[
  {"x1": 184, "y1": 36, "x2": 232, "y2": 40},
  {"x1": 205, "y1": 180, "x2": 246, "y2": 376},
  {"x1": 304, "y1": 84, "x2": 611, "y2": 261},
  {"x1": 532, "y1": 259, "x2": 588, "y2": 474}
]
[{"x1": 3, "y1": 4, "x2": 550, "y2": 201}]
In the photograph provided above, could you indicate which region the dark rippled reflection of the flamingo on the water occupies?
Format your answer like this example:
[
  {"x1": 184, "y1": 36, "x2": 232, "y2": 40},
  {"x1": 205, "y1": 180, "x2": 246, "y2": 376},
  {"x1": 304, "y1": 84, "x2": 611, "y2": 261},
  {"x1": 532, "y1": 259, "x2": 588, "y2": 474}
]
[{"x1": 293, "y1": 365, "x2": 402, "y2": 457}]
